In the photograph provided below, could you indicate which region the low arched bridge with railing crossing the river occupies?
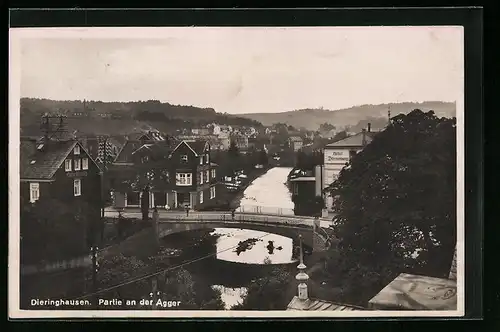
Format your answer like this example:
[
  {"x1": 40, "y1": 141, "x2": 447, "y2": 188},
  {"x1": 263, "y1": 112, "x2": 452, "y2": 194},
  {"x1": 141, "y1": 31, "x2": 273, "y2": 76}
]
[{"x1": 154, "y1": 213, "x2": 330, "y2": 252}]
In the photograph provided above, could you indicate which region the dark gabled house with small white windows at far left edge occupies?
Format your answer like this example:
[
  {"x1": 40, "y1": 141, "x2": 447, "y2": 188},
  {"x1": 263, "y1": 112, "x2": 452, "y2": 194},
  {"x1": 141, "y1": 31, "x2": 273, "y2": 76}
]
[{"x1": 19, "y1": 137, "x2": 101, "y2": 213}]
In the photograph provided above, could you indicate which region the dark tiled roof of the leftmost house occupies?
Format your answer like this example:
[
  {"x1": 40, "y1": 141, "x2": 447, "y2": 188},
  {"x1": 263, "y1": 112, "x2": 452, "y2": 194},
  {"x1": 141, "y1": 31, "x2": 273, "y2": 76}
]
[{"x1": 20, "y1": 140, "x2": 77, "y2": 179}]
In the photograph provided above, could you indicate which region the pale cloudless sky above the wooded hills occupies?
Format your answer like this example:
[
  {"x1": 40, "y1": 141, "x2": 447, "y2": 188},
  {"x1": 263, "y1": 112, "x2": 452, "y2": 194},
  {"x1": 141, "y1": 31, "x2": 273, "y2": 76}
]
[{"x1": 15, "y1": 27, "x2": 463, "y2": 114}]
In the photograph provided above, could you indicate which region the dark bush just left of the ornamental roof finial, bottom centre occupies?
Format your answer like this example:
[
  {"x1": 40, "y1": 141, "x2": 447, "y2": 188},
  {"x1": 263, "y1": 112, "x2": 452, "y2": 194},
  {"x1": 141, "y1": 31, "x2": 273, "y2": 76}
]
[{"x1": 232, "y1": 267, "x2": 294, "y2": 310}]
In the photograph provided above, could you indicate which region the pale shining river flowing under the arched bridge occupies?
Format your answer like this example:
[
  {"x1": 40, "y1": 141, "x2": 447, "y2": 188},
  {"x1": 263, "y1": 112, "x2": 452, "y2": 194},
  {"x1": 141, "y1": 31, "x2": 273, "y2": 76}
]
[{"x1": 164, "y1": 167, "x2": 298, "y2": 309}]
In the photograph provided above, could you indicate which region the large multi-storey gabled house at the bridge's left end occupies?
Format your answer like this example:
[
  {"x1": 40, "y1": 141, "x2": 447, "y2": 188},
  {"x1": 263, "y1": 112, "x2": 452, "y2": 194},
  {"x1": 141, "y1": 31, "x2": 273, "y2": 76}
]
[{"x1": 112, "y1": 139, "x2": 218, "y2": 209}]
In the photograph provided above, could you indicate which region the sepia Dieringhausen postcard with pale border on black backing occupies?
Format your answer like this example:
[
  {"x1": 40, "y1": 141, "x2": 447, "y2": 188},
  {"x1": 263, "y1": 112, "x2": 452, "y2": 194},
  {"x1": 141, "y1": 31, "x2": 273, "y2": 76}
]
[{"x1": 8, "y1": 26, "x2": 465, "y2": 318}]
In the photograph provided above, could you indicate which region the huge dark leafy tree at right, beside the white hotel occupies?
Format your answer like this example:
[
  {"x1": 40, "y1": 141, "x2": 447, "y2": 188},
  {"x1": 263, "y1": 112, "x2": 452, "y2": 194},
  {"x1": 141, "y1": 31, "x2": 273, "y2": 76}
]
[{"x1": 328, "y1": 110, "x2": 456, "y2": 304}]
